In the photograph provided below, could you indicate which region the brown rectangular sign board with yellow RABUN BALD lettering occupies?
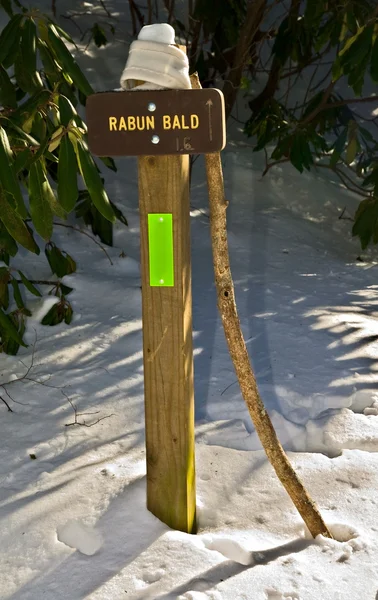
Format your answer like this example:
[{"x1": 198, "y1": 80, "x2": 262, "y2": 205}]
[{"x1": 86, "y1": 88, "x2": 226, "y2": 156}]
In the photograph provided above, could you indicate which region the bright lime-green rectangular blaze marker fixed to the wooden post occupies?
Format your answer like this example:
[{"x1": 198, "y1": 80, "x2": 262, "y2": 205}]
[{"x1": 148, "y1": 213, "x2": 175, "y2": 287}]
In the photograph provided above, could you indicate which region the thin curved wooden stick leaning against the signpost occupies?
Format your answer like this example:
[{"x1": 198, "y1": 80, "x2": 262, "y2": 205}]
[{"x1": 192, "y1": 76, "x2": 332, "y2": 538}]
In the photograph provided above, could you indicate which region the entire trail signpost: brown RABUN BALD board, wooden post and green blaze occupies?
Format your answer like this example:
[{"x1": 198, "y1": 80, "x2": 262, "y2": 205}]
[{"x1": 86, "y1": 89, "x2": 225, "y2": 533}]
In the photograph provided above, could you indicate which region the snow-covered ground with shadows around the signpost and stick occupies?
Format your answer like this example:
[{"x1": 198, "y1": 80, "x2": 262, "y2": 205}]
[{"x1": 0, "y1": 1, "x2": 378, "y2": 600}]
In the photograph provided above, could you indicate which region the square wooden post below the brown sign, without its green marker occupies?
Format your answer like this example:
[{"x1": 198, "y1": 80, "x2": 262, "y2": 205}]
[{"x1": 138, "y1": 155, "x2": 196, "y2": 533}]
